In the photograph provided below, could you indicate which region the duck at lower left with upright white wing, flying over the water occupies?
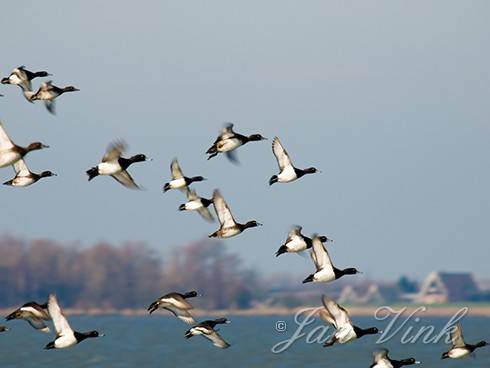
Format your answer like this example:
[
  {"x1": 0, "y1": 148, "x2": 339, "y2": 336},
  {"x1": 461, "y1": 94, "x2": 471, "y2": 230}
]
[{"x1": 45, "y1": 294, "x2": 104, "y2": 350}]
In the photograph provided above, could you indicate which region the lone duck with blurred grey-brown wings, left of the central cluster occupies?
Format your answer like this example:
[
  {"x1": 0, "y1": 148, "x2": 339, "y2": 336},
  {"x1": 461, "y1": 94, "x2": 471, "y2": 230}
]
[{"x1": 86, "y1": 142, "x2": 151, "y2": 189}]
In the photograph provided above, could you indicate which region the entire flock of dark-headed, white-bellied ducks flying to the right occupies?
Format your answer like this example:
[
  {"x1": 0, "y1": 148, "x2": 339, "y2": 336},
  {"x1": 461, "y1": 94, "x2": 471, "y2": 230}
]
[{"x1": 0, "y1": 66, "x2": 488, "y2": 368}]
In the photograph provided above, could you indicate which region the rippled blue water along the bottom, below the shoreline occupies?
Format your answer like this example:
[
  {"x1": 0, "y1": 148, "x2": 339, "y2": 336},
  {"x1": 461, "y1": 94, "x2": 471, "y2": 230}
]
[{"x1": 0, "y1": 315, "x2": 490, "y2": 368}]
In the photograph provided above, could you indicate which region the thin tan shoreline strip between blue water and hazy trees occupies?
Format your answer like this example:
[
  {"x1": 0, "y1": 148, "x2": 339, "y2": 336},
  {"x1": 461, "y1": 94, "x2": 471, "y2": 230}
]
[{"x1": 0, "y1": 304, "x2": 490, "y2": 317}]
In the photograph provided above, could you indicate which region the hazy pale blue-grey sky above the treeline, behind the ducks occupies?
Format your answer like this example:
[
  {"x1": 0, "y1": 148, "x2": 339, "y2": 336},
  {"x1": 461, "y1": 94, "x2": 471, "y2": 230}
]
[{"x1": 0, "y1": 0, "x2": 490, "y2": 279}]
